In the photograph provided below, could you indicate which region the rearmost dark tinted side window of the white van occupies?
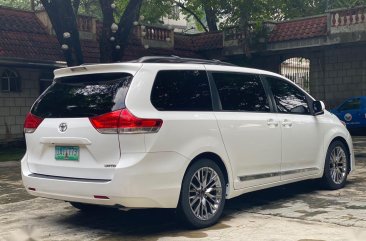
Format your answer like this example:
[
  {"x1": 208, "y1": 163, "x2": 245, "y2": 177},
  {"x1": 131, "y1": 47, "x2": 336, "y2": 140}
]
[{"x1": 151, "y1": 70, "x2": 212, "y2": 111}]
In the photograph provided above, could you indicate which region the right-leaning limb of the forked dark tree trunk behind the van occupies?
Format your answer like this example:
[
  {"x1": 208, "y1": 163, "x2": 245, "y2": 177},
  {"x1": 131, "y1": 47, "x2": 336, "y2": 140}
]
[{"x1": 112, "y1": 0, "x2": 143, "y2": 62}]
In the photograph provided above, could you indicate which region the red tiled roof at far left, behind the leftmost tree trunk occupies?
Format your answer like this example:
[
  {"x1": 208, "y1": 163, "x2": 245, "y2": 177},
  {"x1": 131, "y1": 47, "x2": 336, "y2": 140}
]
[{"x1": 0, "y1": 7, "x2": 99, "y2": 63}]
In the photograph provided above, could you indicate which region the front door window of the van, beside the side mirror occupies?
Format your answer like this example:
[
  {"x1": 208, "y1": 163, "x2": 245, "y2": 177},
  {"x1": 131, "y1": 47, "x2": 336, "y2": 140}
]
[{"x1": 267, "y1": 77, "x2": 310, "y2": 114}]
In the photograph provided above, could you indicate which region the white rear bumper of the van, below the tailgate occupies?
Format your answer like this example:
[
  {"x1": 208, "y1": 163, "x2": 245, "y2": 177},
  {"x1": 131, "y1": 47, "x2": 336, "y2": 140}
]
[{"x1": 21, "y1": 152, "x2": 188, "y2": 208}]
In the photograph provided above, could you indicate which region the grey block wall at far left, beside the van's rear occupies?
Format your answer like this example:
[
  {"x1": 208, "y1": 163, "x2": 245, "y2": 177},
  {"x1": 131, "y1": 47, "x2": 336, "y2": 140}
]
[{"x1": 0, "y1": 66, "x2": 41, "y2": 144}]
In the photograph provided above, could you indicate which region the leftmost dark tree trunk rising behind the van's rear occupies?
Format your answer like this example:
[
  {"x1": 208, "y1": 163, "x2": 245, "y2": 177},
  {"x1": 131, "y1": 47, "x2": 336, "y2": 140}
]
[{"x1": 41, "y1": 0, "x2": 84, "y2": 66}]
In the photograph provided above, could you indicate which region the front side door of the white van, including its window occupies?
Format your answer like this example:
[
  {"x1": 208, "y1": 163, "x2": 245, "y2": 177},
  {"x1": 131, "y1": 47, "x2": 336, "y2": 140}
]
[{"x1": 266, "y1": 77, "x2": 323, "y2": 180}]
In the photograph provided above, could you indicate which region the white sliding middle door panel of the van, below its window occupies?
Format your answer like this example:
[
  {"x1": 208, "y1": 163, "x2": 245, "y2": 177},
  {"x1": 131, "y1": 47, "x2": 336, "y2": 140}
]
[{"x1": 215, "y1": 112, "x2": 281, "y2": 189}]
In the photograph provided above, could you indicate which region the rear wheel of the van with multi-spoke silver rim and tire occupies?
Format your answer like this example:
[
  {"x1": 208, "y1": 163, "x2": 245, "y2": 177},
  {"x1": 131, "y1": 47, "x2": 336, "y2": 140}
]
[{"x1": 177, "y1": 159, "x2": 226, "y2": 228}]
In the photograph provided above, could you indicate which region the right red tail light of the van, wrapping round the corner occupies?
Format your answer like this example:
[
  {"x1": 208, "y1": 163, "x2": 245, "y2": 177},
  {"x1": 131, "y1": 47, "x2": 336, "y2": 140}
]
[{"x1": 89, "y1": 109, "x2": 163, "y2": 134}]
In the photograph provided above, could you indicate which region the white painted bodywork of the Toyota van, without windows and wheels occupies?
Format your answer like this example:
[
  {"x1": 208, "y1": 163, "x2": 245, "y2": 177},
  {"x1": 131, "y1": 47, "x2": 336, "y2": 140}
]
[{"x1": 22, "y1": 63, "x2": 354, "y2": 211}]
